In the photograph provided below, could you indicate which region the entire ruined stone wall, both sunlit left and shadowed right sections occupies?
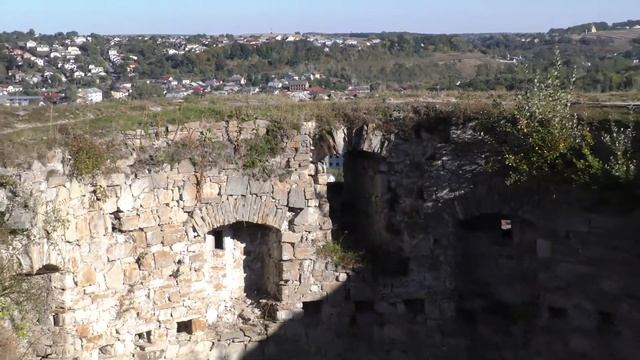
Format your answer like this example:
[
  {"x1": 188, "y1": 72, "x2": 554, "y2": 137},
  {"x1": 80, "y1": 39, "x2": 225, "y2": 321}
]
[{"x1": 0, "y1": 118, "x2": 640, "y2": 359}]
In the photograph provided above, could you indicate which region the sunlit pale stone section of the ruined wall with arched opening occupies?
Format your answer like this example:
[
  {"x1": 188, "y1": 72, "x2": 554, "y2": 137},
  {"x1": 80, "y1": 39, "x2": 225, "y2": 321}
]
[{"x1": 3, "y1": 122, "x2": 348, "y2": 359}]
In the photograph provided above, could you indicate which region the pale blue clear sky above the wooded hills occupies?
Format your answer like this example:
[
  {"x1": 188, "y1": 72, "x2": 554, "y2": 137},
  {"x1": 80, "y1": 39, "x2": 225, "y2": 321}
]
[{"x1": 0, "y1": 0, "x2": 640, "y2": 34}]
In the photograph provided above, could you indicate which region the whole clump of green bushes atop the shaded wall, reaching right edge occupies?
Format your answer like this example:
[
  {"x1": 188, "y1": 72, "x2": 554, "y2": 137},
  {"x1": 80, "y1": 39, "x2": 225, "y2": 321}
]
[{"x1": 494, "y1": 51, "x2": 636, "y2": 184}]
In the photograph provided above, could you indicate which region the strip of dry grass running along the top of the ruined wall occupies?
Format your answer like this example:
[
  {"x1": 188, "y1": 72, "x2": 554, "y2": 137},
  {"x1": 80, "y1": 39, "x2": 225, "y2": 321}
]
[{"x1": 0, "y1": 91, "x2": 640, "y2": 165}]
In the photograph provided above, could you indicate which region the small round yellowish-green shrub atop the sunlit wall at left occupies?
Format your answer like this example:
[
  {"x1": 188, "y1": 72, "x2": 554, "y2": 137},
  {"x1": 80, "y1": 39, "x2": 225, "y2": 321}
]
[{"x1": 67, "y1": 136, "x2": 108, "y2": 177}]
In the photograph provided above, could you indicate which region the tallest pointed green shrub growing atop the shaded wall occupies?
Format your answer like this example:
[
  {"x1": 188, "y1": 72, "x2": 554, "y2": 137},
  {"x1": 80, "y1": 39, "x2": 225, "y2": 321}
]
[{"x1": 503, "y1": 52, "x2": 603, "y2": 184}]
